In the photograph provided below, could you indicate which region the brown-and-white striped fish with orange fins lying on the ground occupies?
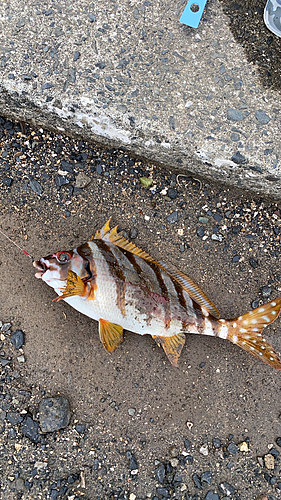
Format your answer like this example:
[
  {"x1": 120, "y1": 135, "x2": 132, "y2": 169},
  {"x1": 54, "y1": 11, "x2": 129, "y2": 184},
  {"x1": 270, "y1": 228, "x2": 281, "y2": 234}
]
[{"x1": 33, "y1": 219, "x2": 281, "y2": 370}]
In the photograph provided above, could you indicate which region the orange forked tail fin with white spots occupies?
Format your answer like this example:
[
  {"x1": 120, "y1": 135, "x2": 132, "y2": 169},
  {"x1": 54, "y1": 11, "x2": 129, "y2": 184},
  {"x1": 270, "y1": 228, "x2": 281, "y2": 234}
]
[{"x1": 224, "y1": 297, "x2": 281, "y2": 370}]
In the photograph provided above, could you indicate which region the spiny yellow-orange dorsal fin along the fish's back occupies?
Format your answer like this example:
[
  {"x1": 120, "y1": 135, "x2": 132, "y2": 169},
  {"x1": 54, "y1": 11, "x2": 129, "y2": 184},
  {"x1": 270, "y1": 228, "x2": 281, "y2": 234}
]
[{"x1": 93, "y1": 219, "x2": 220, "y2": 319}]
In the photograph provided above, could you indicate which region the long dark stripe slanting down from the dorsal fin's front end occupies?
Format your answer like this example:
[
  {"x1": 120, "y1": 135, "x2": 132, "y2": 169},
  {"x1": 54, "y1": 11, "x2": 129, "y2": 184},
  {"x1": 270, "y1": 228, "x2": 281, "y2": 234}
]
[{"x1": 93, "y1": 240, "x2": 126, "y2": 316}]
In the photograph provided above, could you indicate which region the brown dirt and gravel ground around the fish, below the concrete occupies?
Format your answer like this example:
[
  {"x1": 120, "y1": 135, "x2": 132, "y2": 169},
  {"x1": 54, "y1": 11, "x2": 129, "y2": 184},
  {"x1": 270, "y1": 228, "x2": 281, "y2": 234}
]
[{"x1": 0, "y1": 118, "x2": 281, "y2": 500}]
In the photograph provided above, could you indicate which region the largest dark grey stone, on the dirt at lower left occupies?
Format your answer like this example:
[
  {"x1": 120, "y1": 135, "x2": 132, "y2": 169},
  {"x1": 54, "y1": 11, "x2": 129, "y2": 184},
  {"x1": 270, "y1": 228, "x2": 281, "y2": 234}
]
[{"x1": 39, "y1": 396, "x2": 71, "y2": 432}]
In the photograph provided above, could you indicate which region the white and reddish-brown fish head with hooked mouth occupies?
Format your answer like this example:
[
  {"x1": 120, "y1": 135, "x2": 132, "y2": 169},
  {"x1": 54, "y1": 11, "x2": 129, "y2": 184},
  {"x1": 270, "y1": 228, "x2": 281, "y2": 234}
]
[{"x1": 33, "y1": 249, "x2": 89, "y2": 291}]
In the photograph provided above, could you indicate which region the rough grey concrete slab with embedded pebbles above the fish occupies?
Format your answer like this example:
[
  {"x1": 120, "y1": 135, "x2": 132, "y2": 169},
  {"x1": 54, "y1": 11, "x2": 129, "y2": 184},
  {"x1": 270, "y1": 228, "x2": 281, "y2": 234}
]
[{"x1": 0, "y1": 0, "x2": 280, "y2": 198}]
